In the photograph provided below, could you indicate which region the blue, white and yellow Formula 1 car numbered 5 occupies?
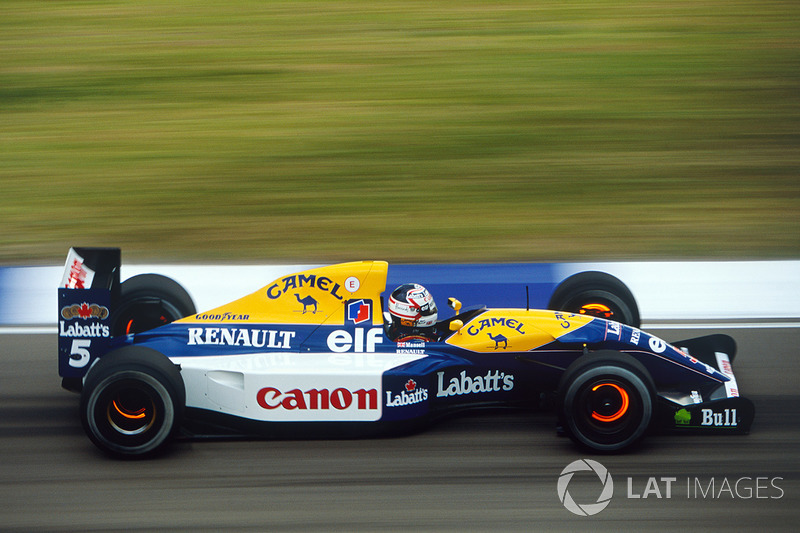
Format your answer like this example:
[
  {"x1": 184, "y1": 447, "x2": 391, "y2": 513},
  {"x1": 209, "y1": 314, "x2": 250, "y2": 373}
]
[{"x1": 58, "y1": 248, "x2": 754, "y2": 458}]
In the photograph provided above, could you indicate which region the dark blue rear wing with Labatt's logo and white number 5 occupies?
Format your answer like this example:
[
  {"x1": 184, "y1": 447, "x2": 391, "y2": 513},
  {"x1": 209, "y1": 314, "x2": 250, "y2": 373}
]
[{"x1": 58, "y1": 248, "x2": 121, "y2": 389}]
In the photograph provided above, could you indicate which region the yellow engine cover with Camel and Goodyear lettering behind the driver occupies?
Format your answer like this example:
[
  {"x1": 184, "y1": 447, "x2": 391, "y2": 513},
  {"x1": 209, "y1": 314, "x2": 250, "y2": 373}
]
[{"x1": 178, "y1": 261, "x2": 389, "y2": 325}]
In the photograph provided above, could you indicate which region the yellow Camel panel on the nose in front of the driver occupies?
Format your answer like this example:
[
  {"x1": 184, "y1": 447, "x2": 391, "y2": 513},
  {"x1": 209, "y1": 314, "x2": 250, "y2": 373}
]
[{"x1": 446, "y1": 309, "x2": 593, "y2": 352}]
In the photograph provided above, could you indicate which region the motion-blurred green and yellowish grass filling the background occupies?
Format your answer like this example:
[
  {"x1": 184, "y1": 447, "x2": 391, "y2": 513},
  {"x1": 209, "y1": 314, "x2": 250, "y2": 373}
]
[{"x1": 0, "y1": 0, "x2": 800, "y2": 264}]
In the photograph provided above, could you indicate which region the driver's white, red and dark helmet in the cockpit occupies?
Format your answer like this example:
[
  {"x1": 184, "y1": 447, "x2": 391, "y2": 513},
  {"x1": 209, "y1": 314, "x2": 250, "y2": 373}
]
[{"x1": 389, "y1": 283, "x2": 438, "y2": 338}]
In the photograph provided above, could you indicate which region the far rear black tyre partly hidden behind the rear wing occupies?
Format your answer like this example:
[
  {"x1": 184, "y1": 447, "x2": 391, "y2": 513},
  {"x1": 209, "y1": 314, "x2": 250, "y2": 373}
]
[{"x1": 111, "y1": 274, "x2": 197, "y2": 336}]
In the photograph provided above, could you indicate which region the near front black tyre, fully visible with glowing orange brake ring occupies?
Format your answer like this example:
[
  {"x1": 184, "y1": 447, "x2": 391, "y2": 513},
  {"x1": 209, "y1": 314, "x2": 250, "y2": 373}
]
[{"x1": 558, "y1": 351, "x2": 655, "y2": 453}]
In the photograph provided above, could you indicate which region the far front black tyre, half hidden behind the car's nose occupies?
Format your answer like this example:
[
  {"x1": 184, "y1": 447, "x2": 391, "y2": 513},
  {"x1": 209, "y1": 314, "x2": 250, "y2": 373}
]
[{"x1": 547, "y1": 272, "x2": 641, "y2": 328}]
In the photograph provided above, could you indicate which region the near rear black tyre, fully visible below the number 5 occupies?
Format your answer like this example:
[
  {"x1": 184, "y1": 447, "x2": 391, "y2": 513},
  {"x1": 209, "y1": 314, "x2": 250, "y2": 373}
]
[{"x1": 80, "y1": 346, "x2": 186, "y2": 458}]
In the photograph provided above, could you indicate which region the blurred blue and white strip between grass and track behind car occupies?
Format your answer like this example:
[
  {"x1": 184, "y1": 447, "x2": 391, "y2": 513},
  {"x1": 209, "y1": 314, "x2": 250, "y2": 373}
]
[{"x1": 0, "y1": 260, "x2": 800, "y2": 326}]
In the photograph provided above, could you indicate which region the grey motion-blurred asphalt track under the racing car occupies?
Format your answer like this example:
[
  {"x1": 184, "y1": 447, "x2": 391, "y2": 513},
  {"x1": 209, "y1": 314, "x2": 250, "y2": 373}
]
[{"x1": 0, "y1": 328, "x2": 800, "y2": 532}]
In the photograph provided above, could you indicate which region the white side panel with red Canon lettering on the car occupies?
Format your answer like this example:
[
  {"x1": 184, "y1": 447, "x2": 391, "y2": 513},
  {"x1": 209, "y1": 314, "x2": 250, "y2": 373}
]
[{"x1": 171, "y1": 352, "x2": 426, "y2": 422}]
